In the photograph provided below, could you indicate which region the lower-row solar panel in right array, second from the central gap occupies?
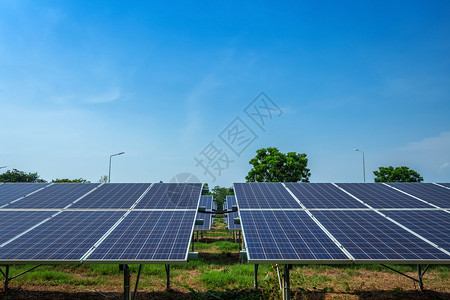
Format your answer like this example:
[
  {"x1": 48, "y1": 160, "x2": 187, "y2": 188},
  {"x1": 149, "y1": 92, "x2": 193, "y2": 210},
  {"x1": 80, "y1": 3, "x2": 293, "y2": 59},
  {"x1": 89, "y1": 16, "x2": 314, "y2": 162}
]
[{"x1": 311, "y1": 210, "x2": 450, "y2": 262}]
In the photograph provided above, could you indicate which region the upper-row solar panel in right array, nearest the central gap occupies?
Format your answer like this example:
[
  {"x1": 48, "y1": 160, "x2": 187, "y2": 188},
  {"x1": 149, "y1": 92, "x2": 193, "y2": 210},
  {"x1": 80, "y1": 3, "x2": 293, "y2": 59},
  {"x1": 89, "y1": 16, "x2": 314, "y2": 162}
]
[{"x1": 234, "y1": 182, "x2": 301, "y2": 209}]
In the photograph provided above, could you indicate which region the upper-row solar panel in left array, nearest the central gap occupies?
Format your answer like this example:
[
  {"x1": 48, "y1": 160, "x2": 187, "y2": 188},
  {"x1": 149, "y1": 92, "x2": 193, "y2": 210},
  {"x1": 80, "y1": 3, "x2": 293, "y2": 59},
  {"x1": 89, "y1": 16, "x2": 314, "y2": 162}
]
[{"x1": 136, "y1": 183, "x2": 202, "y2": 209}]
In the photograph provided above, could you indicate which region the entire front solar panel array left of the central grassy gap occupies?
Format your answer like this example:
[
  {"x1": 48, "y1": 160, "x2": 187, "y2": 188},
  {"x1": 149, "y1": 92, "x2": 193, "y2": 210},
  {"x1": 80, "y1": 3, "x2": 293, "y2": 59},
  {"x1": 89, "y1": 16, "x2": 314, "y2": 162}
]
[{"x1": 0, "y1": 183, "x2": 202, "y2": 264}]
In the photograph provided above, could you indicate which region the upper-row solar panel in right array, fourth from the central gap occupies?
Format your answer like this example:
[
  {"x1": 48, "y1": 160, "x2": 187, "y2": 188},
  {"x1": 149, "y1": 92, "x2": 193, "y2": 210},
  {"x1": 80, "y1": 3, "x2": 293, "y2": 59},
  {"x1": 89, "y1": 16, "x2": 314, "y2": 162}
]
[{"x1": 388, "y1": 183, "x2": 450, "y2": 208}]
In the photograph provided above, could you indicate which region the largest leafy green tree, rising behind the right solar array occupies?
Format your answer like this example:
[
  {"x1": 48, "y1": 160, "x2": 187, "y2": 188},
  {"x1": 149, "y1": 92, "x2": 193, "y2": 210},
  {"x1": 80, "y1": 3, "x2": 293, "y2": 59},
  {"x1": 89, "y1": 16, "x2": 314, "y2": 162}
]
[{"x1": 245, "y1": 147, "x2": 311, "y2": 182}]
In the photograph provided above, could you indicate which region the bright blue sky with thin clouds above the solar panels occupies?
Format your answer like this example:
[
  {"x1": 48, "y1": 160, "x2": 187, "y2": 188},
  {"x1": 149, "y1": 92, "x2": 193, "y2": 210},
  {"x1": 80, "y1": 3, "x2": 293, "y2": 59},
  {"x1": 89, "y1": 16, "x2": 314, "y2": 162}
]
[{"x1": 0, "y1": 0, "x2": 450, "y2": 186}]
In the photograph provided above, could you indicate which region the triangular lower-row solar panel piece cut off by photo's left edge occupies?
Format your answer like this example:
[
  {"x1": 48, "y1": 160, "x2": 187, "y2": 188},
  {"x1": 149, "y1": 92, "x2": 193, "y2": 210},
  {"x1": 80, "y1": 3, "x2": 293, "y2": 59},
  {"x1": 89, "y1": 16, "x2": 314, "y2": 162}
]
[{"x1": 0, "y1": 211, "x2": 55, "y2": 244}]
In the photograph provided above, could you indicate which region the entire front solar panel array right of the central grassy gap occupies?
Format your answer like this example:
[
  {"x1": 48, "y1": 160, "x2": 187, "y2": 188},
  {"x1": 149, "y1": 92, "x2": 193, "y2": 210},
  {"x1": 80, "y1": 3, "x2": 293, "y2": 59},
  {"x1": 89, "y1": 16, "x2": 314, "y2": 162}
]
[{"x1": 235, "y1": 183, "x2": 450, "y2": 263}]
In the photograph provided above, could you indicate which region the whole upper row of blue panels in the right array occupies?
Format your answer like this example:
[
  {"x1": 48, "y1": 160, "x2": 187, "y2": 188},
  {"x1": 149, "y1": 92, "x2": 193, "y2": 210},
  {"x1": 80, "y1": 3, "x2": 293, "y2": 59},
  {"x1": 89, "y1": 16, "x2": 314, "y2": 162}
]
[{"x1": 234, "y1": 183, "x2": 450, "y2": 209}]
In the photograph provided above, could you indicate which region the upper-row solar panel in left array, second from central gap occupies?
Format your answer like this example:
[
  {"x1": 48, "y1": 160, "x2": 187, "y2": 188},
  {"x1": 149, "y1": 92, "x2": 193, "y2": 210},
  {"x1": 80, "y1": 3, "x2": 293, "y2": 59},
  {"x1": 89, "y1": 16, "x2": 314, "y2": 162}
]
[{"x1": 70, "y1": 183, "x2": 150, "y2": 209}]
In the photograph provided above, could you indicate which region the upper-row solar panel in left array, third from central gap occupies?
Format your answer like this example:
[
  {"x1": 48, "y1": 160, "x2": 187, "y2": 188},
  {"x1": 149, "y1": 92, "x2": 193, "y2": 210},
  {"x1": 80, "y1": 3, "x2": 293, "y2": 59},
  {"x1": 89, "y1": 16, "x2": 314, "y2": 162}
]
[{"x1": 5, "y1": 183, "x2": 99, "y2": 208}]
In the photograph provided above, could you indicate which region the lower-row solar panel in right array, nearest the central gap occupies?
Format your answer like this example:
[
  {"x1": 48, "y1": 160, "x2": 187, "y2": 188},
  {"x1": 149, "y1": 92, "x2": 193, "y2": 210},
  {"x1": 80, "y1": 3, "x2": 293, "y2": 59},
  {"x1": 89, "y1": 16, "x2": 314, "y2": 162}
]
[{"x1": 240, "y1": 210, "x2": 349, "y2": 263}]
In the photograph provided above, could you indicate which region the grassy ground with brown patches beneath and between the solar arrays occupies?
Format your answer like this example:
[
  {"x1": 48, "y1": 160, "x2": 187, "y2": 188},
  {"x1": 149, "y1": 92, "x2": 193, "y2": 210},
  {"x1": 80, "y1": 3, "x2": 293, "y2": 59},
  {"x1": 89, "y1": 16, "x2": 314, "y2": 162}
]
[{"x1": 0, "y1": 219, "x2": 450, "y2": 299}]
